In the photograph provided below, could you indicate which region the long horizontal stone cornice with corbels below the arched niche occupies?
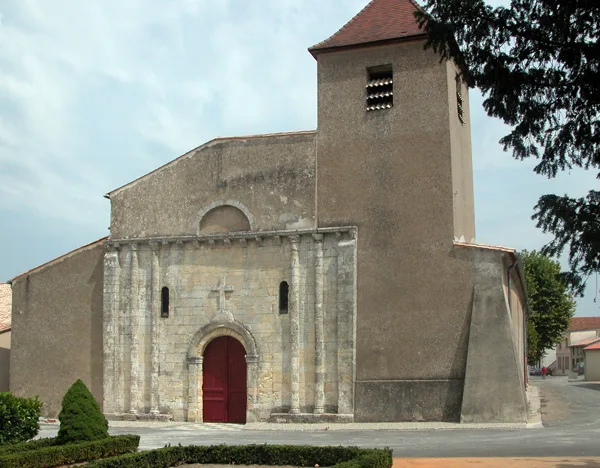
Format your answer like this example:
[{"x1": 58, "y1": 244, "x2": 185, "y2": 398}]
[{"x1": 104, "y1": 226, "x2": 358, "y2": 248}]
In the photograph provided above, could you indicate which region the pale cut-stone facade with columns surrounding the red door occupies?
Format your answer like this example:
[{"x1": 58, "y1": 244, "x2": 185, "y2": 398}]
[{"x1": 104, "y1": 229, "x2": 356, "y2": 421}]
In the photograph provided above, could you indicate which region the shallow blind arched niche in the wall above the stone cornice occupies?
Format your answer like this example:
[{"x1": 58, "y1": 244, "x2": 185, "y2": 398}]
[{"x1": 198, "y1": 200, "x2": 252, "y2": 234}]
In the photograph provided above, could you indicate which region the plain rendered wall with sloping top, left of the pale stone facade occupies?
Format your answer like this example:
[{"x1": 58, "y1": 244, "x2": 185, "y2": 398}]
[{"x1": 10, "y1": 242, "x2": 104, "y2": 417}]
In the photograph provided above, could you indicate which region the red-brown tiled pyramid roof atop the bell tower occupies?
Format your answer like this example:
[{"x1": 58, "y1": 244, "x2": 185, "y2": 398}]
[{"x1": 308, "y1": 0, "x2": 424, "y2": 56}]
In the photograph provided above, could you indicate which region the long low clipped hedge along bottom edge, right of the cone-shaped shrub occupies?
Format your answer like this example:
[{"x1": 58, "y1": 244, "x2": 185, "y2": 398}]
[{"x1": 86, "y1": 445, "x2": 392, "y2": 468}]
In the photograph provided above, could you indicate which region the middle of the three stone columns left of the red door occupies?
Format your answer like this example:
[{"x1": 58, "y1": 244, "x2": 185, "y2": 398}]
[{"x1": 129, "y1": 244, "x2": 141, "y2": 414}]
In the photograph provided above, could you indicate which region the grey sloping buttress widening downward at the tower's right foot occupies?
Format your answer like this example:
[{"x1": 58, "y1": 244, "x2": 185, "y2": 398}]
[{"x1": 456, "y1": 245, "x2": 527, "y2": 423}]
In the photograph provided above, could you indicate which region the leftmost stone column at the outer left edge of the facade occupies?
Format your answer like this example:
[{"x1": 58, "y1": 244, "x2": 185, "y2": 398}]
[{"x1": 102, "y1": 245, "x2": 123, "y2": 413}]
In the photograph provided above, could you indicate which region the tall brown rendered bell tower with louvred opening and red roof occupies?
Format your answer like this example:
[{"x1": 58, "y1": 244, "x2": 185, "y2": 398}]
[{"x1": 309, "y1": 0, "x2": 475, "y2": 421}]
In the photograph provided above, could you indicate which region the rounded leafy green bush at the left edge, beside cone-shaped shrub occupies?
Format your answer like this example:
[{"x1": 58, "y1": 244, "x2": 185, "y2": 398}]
[{"x1": 0, "y1": 392, "x2": 42, "y2": 445}]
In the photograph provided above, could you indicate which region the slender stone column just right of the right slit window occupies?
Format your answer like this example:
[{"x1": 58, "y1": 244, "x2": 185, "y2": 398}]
[{"x1": 289, "y1": 236, "x2": 300, "y2": 414}]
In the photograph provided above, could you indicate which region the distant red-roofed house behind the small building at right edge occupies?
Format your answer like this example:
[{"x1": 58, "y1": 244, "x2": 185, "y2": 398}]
[{"x1": 554, "y1": 317, "x2": 600, "y2": 375}]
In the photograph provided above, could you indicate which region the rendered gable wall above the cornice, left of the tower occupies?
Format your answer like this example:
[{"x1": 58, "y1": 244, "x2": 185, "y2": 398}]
[{"x1": 110, "y1": 132, "x2": 316, "y2": 239}]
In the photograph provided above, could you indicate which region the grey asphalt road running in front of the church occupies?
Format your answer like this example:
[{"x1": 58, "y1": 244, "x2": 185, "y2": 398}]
[{"x1": 40, "y1": 377, "x2": 600, "y2": 458}]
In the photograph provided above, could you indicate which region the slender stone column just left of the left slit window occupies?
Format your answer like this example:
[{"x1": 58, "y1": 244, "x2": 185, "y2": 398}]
[{"x1": 150, "y1": 242, "x2": 161, "y2": 414}]
